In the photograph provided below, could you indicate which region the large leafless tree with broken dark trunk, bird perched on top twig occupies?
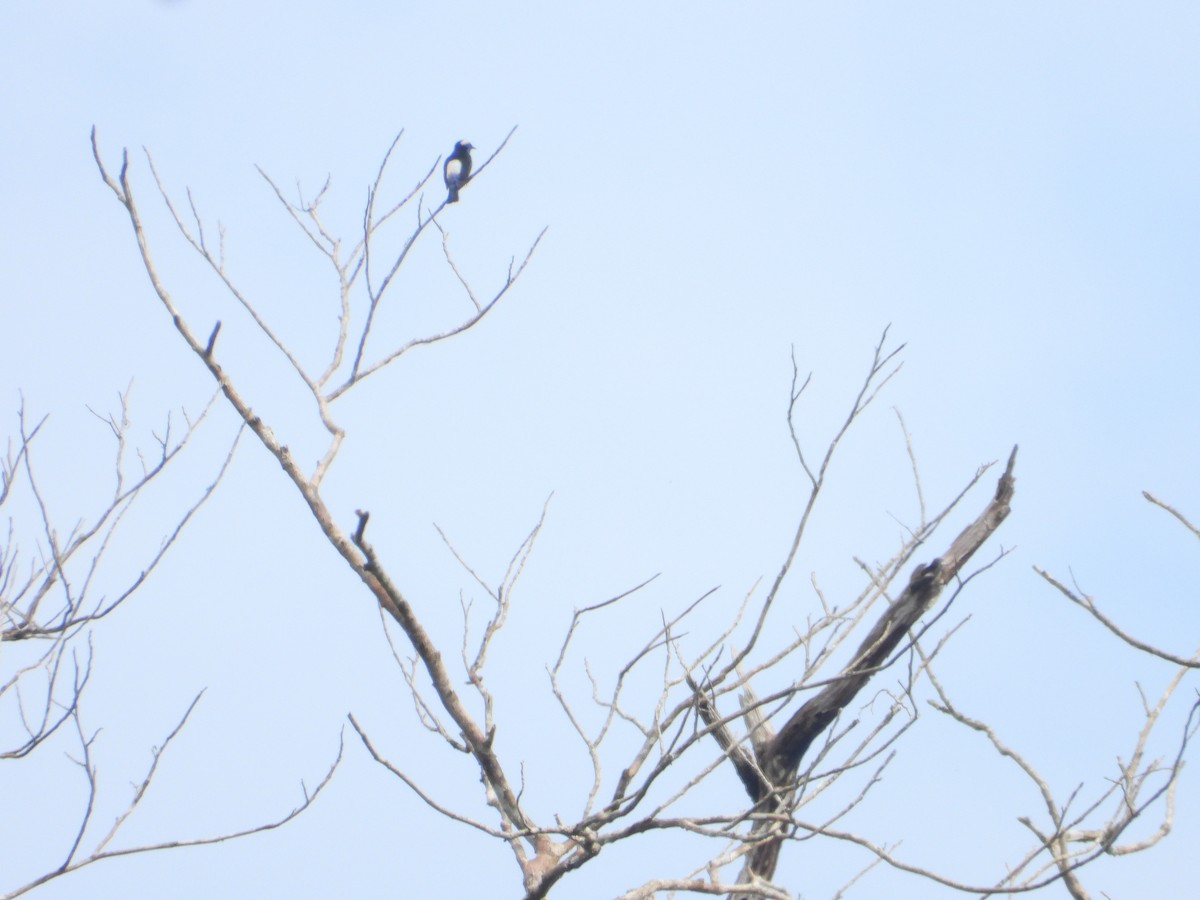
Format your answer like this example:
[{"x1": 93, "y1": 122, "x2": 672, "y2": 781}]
[{"x1": 82, "y1": 132, "x2": 1195, "y2": 900}]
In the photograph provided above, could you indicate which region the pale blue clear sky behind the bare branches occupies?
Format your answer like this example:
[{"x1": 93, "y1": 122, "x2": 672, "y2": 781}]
[{"x1": 0, "y1": 0, "x2": 1200, "y2": 898}]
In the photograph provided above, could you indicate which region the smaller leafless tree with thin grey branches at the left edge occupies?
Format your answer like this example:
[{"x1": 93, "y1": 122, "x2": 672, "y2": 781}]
[{"x1": 0, "y1": 391, "x2": 336, "y2": 898}]
